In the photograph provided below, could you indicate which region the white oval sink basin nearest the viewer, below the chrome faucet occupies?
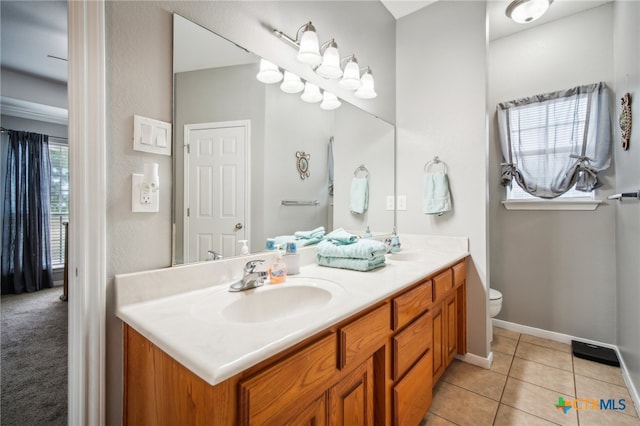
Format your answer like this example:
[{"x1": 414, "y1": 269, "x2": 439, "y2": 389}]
[{"x1": 192, "y1": 277, "x2": 345, "y2": 323}]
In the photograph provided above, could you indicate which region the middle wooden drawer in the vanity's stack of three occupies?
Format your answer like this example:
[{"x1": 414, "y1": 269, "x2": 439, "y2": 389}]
[{"x1": 393, "y1": 312, "x2": 433, "y2": 380}]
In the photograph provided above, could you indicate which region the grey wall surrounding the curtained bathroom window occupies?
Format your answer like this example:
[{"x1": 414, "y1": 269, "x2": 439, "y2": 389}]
[{"x1": 489, "y1": 4, "x2": 616, "y2": 343}]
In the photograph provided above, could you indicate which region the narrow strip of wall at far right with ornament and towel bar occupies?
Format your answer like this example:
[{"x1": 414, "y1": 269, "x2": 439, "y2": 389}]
[{"x1": 613, "y1": 1, "x2": 640, "y2": 404}]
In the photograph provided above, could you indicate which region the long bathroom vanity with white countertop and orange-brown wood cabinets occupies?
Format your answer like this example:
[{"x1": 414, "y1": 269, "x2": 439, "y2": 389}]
[{"x1": 116, "y1": 238, "x2": 468, "y2": 425}]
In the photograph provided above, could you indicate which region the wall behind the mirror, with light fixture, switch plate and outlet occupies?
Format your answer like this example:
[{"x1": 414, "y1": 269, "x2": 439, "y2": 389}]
[{"x1": 105, "y1": 1, "x2": 395, "y2": 424}]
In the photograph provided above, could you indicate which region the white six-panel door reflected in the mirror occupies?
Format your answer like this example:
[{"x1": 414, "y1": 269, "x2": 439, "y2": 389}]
[{"x1": 184, "y1": 121, "x2": 249, "y2": 262}]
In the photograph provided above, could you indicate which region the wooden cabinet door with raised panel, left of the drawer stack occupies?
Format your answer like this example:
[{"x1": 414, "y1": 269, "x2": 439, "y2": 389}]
[{"x1": 329, "y1": 358, "x2": 374, "y2": 426}]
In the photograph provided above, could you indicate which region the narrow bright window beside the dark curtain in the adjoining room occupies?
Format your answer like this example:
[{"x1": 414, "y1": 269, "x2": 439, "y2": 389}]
[{"x1": 49, "y1": 138, "x2": 69, "y2": 268}]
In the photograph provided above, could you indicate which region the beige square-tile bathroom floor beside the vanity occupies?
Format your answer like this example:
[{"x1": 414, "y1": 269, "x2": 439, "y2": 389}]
[{"x1": 421, "y1": 327, "x2": 640, "y2": 426}]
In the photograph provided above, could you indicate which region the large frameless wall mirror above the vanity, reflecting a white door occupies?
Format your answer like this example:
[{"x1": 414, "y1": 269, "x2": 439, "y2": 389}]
[{"x1": 173, "y1": 14, "x2": 395, "y2": 264}]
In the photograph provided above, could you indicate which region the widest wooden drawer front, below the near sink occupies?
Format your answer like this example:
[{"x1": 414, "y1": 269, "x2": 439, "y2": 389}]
[{"x1": 239, "y1": 334, "x2": 338, "y2": 425}]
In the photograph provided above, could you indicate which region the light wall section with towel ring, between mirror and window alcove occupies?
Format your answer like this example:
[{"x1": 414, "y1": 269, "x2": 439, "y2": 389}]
[{"x1": 396, "y1": 1, "x2": 489, "y2": 357}]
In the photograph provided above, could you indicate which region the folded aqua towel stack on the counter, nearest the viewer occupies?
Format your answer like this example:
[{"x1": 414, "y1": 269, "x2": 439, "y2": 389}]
[{"x1": 316, "y1": 240, "x2": 386, "y2": 271}]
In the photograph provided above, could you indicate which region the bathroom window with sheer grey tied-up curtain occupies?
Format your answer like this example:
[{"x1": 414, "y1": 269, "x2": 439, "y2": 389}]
[{"x1": 498, "y1": 83, "x2": 611, "y2": 200}]
